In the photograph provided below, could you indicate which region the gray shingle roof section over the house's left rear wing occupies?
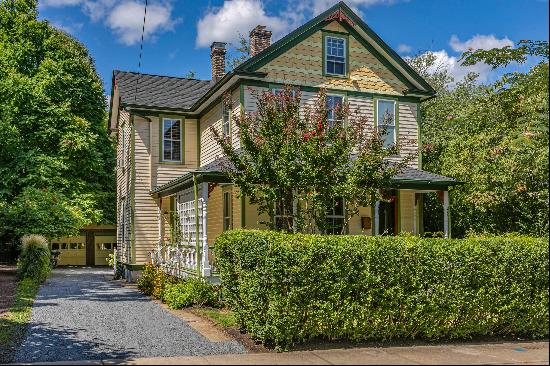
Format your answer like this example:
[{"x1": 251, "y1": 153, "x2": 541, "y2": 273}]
[{"x1": 114, "y1": 70, "x2": 214, "y2": 109}]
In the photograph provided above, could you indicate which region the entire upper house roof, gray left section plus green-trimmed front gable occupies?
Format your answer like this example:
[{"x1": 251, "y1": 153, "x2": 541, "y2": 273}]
[{"x1": 111, "y1": 1, "x2": 435, "y2": 117}]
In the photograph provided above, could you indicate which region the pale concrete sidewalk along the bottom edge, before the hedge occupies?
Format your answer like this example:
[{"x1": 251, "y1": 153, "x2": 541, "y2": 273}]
[{"x1": 28, "y1": 341, "x2": 548, "y2": 365}]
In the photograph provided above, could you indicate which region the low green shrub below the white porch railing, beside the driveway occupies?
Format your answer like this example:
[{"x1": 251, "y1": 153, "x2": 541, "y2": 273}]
[{"x1": 163, "y1": 278, "x2": 219, "y2": 309}]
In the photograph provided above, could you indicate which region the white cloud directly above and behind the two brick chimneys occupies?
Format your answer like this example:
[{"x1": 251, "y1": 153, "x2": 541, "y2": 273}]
[{"x1": 196, "y1": 0, "x2": 290, "y2": 47}]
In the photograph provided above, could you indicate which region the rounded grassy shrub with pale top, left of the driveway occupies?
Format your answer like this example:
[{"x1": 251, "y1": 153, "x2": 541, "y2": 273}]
[{"x1": 17, "y1": 235, "x2": 51, "y2": 282}]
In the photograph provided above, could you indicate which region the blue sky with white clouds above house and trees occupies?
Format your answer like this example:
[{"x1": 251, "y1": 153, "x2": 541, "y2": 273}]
[{"x1": 39, "y1": 0, "x2": 548, "y2": 95}]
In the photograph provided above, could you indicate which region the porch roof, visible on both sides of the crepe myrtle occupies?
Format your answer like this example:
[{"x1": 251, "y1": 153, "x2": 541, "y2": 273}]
[{"x1": 151, "y1": 157, "x2": 463, "y2": 197}]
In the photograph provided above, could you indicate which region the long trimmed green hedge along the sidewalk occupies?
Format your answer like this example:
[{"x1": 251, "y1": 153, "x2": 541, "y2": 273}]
[{"x1": 215, "y1": 230, "x2": 549, "y2": 348}]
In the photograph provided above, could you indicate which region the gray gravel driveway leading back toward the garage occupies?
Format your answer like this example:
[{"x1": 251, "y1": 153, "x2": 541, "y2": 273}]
[{"x1": 15, "y1": 268, "x2": 244, "y2": 362}]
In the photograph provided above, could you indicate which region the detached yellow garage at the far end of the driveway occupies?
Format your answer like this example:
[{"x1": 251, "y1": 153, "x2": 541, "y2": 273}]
[{"x1": 50, "y1": 225, "x2": 116, "y2": 266}]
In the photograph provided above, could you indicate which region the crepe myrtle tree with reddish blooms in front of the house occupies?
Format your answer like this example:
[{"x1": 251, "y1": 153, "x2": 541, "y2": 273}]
[{"x1": 212, "y1": 86, "x2": 413, "y2": 233}]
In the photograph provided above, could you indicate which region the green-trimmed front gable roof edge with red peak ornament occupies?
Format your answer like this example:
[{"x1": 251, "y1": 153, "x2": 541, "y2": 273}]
[{"x1": 235, "y1": 1, "x2": 435, "y2": 95}]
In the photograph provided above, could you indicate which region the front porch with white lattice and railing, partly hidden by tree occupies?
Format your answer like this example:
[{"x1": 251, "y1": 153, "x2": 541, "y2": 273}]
[{"x1": 151, "y1": 162, "x2": 460, "y2": 278}]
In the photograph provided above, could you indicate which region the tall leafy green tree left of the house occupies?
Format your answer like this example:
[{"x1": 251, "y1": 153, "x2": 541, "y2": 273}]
[{"x1": 0, "y1": 0, "x2": 115, "y2": 246}]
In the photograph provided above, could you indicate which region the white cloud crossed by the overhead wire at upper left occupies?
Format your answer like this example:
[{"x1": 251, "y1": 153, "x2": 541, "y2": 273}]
[{"x1": 40, "y1": 0, "x2": 179, "y2": 46}]
